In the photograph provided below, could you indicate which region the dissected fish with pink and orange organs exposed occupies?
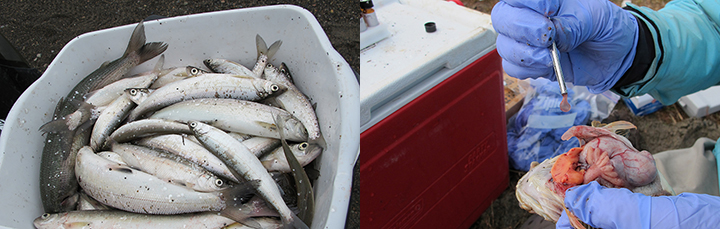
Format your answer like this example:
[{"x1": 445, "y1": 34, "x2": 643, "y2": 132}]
[{"x1": 515, "y1": 121, "x2": 669, "y2": 227}]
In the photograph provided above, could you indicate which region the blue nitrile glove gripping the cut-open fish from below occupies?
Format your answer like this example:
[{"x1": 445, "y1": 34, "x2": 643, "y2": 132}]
[{"x1": 556, "y1": 181, "x2": 720, "y2": 228}]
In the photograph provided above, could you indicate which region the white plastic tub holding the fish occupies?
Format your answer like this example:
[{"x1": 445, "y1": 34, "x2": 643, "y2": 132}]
[{"x1": 0, "y1": 5, "x2": 360, "y2": 228}]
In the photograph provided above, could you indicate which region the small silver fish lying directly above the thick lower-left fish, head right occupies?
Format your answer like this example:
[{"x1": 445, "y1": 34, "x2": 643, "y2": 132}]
[{"x1": 112, "y1": 144, "x2": 227, "y2": 192}]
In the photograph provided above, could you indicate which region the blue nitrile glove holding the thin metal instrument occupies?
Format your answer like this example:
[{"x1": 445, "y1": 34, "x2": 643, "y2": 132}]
[{"x1": 490, "y1": 0, "x2": 638, "y2": 93}]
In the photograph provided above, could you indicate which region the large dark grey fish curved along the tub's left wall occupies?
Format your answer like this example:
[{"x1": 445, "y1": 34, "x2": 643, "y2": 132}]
[{"x1": 40, "y1": 22, "x2": 167, "y2": 213}]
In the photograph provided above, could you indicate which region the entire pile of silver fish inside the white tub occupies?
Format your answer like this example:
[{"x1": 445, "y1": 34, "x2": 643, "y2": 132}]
[{"x1": 34, "y1": 22, "x2": 322, "y2": 228}]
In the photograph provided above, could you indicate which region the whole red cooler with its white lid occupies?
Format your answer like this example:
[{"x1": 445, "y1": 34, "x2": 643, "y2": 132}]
[{"x1": 359, "y1": 0, "x2": 508, "y2": 228}]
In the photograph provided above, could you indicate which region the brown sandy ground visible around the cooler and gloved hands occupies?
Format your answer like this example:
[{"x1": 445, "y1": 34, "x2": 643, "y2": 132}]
[{"x1": 463, "y1": 0, "x2": 720, "y2": 229}]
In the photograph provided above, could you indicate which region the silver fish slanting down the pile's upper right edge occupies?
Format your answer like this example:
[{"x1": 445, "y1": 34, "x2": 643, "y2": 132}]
[{"x1": 265, "y1": 63, "x2": 320, "y2": 141}]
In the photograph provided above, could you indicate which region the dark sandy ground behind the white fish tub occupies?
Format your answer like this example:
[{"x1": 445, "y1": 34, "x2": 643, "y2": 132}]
[{"x1": 0, "y1": 0, "x2": 360, "y2": 228}]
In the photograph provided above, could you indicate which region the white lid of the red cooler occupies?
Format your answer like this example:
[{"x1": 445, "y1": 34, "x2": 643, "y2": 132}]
[{"x1": 360, "y1": 0, "x2": 497, "y2": 131}]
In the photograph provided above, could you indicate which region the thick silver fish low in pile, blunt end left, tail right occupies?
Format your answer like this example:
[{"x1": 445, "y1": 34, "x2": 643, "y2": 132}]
[{"x1": 75, "y1": 147, "x2": 252, "y2": 220}]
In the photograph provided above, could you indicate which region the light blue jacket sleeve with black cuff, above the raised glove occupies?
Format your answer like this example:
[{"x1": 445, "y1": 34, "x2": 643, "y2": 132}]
[{"x1": 614, "y1": 0, "x2": 720, "y2": 105}]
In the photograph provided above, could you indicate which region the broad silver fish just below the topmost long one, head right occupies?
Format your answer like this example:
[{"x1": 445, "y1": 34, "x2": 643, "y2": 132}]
[{"x1": 150, "y1": 98, "x2": 307, "y2": 142}]
